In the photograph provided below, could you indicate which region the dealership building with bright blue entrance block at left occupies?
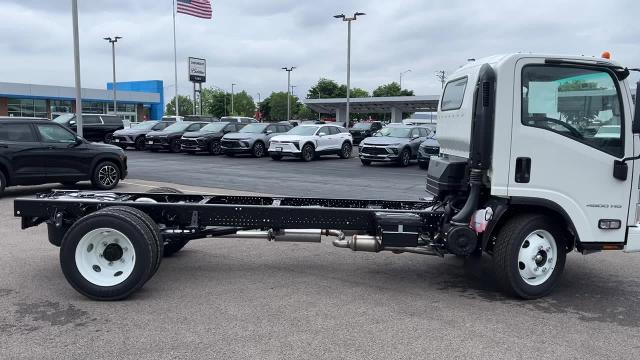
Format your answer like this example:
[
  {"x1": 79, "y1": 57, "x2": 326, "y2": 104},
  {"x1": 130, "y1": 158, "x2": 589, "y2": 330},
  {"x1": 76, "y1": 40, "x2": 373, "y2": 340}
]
[{"x1": 0, "y1": 80, "x2": 164, "y2": 122}]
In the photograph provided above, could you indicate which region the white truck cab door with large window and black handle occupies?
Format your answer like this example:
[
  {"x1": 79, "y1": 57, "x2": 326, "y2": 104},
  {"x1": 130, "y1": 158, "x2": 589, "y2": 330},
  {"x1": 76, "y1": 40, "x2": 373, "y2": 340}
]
[{"x1": 508, "y1": 59, "x2": 633, "y2": 243}]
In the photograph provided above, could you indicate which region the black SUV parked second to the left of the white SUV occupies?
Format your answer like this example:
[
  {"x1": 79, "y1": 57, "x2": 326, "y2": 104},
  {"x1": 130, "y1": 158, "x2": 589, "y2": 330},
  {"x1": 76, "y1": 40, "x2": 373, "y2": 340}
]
[{"x1": 180, "y1": 122, "x2": 246, "y2": 155}]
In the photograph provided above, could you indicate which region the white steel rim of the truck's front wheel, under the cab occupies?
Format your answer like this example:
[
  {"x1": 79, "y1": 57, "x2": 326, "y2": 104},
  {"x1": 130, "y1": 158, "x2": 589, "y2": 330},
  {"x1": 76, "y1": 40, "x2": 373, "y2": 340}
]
[{"x1": 517, "y1": 230, "x2": 558, "y2": 286}]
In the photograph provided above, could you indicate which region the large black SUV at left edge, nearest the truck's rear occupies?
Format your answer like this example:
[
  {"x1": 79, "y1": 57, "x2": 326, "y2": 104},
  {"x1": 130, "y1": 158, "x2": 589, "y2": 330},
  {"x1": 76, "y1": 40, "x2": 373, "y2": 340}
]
[{"x1": 0, "y1": 117, "x2": 127, "y2": 194}]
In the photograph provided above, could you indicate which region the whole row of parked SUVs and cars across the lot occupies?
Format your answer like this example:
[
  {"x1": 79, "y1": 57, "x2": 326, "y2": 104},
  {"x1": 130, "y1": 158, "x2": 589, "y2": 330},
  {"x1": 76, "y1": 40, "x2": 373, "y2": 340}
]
[{"x1": 112, "y1": 117, "x2": 439, "y2": 168}]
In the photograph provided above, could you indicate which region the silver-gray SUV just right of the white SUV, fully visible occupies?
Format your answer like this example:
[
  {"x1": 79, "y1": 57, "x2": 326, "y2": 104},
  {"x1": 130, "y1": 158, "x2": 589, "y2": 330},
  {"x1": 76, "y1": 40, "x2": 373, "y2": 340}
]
[{"x1": 359, "y1": 126, "x2": 429, "y2": 166}]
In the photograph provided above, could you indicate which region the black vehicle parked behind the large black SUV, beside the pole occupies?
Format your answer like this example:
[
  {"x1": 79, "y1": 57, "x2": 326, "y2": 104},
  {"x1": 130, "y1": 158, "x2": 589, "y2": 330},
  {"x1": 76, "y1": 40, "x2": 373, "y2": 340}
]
[{"x1": 53, "y1": 114, "x2": 124, "y2": 144}]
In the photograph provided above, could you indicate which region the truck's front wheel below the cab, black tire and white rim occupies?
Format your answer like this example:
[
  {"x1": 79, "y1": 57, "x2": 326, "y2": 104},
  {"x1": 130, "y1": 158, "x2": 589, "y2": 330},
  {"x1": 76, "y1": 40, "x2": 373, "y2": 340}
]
[{"x1": 493, "y1": 214, "x2": 567, "y2": 299}]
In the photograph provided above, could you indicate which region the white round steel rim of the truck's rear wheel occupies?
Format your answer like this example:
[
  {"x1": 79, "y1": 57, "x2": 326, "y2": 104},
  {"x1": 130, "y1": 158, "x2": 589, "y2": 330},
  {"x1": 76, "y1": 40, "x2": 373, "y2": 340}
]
[{"x1": 75, "y1": 228, "x2": 136, "y2": 286}]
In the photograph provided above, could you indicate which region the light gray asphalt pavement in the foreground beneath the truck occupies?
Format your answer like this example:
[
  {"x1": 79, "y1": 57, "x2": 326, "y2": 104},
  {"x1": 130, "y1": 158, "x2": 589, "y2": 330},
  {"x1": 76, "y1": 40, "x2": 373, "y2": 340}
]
[{"x1": 0, "y1": 179, "x2": 640, "y2": 359}]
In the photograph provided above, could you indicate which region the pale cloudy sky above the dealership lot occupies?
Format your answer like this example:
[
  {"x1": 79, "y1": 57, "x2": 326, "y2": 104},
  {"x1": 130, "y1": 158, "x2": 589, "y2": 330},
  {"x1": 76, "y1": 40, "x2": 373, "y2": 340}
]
[{"x1": 0, "y1": 0, "x2": 640, "y2": 100}]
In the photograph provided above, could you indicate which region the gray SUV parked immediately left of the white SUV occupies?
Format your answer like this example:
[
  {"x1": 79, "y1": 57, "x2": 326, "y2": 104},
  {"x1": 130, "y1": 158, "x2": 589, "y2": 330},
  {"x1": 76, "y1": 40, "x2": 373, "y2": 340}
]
[{"x1": 221, "y1": 123, "x2": 293, "y2": 157}]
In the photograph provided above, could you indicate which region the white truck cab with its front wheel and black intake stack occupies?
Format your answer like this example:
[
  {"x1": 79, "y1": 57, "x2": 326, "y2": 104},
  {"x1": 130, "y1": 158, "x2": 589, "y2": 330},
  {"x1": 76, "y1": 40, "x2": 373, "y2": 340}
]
[{"x1": 427, "y1": 54, "x2": 640, "y2": 297}]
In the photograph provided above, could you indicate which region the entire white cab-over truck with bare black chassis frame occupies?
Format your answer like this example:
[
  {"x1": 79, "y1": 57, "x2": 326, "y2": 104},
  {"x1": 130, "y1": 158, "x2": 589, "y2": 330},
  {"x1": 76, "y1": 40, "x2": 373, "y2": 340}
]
[{"x1": 15, "y1": 54, "x2": 640, "y2": 300}]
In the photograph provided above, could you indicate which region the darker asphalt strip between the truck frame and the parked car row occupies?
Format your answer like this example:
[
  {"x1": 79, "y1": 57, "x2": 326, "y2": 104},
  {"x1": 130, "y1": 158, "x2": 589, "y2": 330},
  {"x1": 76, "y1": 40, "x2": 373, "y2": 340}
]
[{"x1": 127, "y1": 149, "x2": 427, "y2": 200}]
